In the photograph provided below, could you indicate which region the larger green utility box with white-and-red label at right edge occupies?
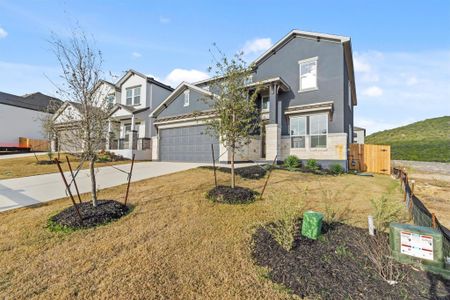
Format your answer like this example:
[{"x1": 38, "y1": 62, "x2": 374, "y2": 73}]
[{"x1": 389, "y1": 223, "x2": 450, "y2": 277}]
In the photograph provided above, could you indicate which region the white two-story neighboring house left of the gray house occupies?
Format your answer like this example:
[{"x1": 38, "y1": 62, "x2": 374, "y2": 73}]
[{"x1": 54, "y1": 70, "x2": 173, "y2": 160}]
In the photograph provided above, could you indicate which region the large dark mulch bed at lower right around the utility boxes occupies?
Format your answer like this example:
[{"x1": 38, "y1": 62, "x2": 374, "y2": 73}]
[{"x1": 252, "y1": 224, "x2": 450, "y2": 299}]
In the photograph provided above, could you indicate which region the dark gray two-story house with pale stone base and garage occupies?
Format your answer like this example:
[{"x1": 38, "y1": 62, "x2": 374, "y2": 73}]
[{"x1": 150, "y1": 30, "x2": 357, "y2": 168}]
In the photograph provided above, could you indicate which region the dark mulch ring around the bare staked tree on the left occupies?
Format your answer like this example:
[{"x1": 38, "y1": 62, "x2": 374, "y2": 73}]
[{"x1": 50, "y1": 200, "x2": 130, "y2": 229}]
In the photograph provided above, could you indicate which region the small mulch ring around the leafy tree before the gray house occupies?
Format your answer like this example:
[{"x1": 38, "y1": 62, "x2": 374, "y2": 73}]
[{"x1": 206, "y1": 185, "x2": 256, "y2": 204}]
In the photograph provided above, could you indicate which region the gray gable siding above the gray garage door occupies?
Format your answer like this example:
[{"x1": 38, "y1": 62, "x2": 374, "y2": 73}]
[{"x1": 158, "y1": 90, "x2": 211, "y2": 118}]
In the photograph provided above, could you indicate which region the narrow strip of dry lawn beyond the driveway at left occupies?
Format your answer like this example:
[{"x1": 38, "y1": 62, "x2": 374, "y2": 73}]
[{"x1": 0, "y1": 154, "x2": 130, "y2": 179}]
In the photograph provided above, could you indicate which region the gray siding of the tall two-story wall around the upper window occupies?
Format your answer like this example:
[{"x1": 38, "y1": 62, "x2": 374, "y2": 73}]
[{"x1": 253, "y1": 37, "x2": 345, "y2": 134}]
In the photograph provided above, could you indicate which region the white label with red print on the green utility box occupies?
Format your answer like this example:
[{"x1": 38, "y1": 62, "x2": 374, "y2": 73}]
[{"x1": 400, "y1": 231, "x2": 433, "y2": 260}]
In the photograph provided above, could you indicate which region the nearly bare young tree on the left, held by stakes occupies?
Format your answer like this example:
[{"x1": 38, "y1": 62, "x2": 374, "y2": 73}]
[{"x1": 46, "y1": 29, "x2": 109, "y2": 207}]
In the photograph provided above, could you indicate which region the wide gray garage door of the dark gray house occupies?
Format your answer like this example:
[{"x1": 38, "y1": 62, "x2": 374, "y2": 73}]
[{"x1": 159, "y1": 125, "x2": 219, "y2": 162}]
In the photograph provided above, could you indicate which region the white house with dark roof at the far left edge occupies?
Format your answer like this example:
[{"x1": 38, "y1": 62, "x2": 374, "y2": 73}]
[{"x1": 0, "y1": 92, "x2": 62, "y2": 146}]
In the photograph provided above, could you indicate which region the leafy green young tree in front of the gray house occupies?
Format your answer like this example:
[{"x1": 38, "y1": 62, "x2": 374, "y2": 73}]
[{"x1": 206, "y1": 48, "x2": 259, "y2": 188}]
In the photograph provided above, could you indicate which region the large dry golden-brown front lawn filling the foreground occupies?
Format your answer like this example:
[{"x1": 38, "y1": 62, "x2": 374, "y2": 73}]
[{"x1": 0, "y1": 169, "x2": 402, "y2": 299}]
